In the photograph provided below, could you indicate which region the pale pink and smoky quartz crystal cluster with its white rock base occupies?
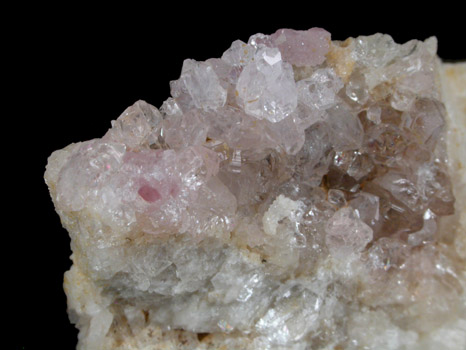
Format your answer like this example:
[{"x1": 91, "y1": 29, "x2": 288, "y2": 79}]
[{"x1": 45, "y1": 28, "x2": 466, "y2": 350}]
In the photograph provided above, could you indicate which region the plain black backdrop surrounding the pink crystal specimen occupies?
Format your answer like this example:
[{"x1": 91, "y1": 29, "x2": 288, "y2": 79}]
[{"x1": 12, "y1": 2, "x2": 466, "y2": 350}]
